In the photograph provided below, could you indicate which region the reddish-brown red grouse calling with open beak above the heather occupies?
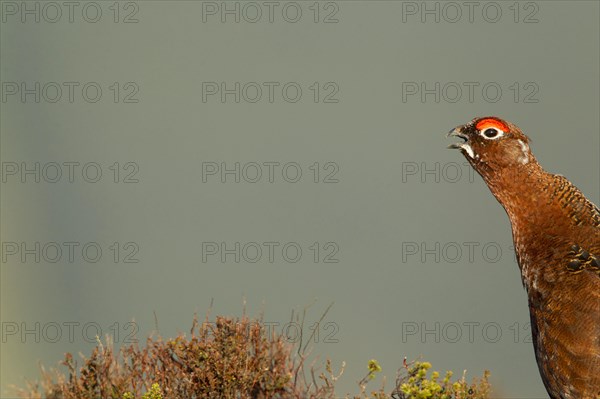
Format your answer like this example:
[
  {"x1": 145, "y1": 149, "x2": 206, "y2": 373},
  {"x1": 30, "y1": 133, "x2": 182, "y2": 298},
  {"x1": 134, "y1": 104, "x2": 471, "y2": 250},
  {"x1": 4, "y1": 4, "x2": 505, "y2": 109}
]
[{"x1": 448, "y1": 116, "x2": 600, "y2": 399}]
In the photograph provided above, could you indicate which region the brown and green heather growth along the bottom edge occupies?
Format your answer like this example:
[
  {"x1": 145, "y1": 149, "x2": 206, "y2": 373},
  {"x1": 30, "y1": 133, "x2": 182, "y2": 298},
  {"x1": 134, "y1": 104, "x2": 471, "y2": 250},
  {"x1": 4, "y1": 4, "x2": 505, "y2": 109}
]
[{"x1": 12, "y1": 311, "x2": 489, "y2": 399}]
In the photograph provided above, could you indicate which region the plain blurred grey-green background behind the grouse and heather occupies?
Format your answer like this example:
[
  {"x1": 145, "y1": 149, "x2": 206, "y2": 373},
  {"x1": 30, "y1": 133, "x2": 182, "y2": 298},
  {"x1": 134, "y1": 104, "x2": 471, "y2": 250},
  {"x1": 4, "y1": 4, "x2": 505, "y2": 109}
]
[{"x1": 0, "y1": 1, "x2": 600, "y2": 398}]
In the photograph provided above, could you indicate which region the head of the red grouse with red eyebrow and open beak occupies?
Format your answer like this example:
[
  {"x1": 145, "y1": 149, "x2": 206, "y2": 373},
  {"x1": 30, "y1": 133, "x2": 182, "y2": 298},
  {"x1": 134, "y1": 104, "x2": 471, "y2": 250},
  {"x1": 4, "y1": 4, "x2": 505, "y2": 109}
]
[{"x1": 448, "y1": 116, "x2": 535, "y2": 173}]
